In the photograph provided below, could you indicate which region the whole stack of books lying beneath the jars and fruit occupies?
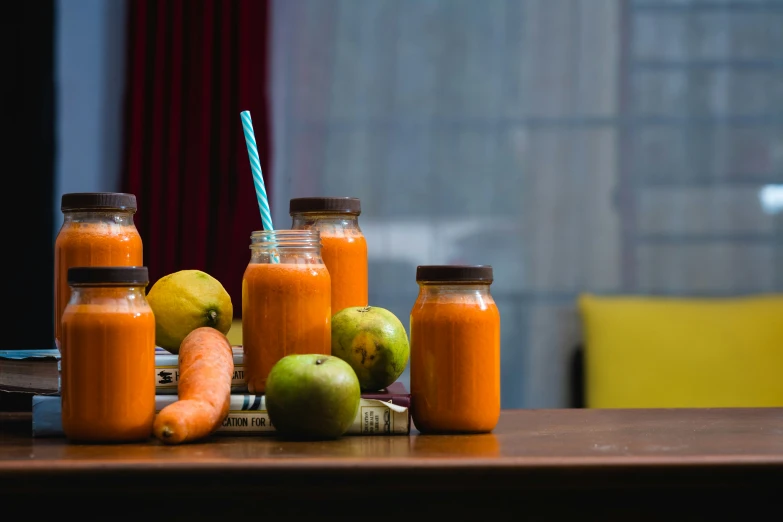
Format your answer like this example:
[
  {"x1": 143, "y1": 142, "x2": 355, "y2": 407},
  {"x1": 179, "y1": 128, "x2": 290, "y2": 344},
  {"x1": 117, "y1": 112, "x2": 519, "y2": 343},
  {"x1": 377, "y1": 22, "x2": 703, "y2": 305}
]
[{"x1": 0, "y1": 346, "x2": 411, "y2": 437}]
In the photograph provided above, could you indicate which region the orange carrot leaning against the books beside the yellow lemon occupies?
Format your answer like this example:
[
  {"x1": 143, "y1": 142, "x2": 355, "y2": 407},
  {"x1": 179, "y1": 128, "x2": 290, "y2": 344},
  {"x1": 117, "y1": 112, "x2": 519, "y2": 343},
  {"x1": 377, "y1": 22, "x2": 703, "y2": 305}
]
[{"x1": 152, "y1": 326, "x2": 234, "y2": 444}]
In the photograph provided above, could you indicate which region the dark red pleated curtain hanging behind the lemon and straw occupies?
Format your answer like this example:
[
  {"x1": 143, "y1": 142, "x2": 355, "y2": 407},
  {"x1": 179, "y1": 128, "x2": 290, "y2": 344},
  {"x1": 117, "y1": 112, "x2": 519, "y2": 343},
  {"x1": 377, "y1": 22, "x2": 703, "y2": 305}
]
[{"x1": 123, "y1": 0, "x2": 273, "y2": 317}]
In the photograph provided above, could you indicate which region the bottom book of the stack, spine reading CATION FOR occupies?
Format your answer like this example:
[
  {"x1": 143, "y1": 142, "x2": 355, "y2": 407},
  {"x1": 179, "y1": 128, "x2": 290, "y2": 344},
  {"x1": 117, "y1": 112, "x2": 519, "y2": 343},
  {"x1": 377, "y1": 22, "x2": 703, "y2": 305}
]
[{"x1": 32, "y1": 395, "x2": 411, "y2": 437}]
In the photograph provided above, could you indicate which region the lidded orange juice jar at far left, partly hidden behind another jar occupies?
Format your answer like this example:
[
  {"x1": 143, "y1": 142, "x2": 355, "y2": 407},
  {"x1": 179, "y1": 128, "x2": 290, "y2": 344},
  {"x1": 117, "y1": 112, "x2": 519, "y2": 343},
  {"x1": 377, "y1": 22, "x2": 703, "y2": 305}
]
[{"x1": 54, "y1": 192, "x2": 144, "y2": 348}]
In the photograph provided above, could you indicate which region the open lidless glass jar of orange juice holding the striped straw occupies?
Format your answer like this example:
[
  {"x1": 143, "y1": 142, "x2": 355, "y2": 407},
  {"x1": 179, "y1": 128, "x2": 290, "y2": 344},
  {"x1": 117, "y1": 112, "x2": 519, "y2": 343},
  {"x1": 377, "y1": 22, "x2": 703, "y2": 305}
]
[{"x1": 242, "y1": 230, "x2": 332, "y2": 394}]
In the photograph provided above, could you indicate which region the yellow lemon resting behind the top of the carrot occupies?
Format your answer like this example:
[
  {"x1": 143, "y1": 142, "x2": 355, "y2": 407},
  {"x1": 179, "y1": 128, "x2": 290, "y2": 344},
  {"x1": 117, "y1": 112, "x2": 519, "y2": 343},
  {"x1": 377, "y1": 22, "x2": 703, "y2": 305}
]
[{"x1": 147, "y1": 270, "x2": 234, "y2": 353}]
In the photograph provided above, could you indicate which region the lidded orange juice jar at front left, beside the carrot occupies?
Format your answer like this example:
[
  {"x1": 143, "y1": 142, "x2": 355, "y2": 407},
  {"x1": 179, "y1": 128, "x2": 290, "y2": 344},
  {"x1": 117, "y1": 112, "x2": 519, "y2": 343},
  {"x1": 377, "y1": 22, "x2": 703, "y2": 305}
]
[{"x1": 60, "y1": 266, "x2": 155, "y2": 442}]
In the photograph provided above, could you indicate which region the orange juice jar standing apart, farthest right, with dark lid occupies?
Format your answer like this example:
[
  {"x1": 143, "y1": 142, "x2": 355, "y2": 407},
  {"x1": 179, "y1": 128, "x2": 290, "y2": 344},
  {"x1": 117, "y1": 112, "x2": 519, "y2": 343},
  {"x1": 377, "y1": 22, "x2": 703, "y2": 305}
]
[{"x1": 410, "y1": 265, "x2": 500, "y2": 433}]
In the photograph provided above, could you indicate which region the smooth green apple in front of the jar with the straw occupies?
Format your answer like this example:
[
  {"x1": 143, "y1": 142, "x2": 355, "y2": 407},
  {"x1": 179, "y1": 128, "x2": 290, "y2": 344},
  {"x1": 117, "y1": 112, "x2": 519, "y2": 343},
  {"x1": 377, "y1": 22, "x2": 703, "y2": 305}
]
[{"x1": 265, "y1": 354, "x2": 361, "y2": 439}]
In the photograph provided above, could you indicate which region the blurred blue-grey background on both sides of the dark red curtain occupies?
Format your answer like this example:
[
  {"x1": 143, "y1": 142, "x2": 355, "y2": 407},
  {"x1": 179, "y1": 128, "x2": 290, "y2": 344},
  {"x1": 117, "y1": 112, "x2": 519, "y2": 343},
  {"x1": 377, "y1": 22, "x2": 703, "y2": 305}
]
[{"x1": 24, "y1": 0, "x2": 783, "y2": 408}]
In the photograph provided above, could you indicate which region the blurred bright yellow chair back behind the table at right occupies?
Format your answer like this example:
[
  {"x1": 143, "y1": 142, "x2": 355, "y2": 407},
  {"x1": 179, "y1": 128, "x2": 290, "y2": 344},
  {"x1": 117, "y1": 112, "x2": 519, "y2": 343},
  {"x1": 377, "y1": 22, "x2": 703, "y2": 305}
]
[{"x1": 578, "y1": 294, "x2": 783, "y2": 408}]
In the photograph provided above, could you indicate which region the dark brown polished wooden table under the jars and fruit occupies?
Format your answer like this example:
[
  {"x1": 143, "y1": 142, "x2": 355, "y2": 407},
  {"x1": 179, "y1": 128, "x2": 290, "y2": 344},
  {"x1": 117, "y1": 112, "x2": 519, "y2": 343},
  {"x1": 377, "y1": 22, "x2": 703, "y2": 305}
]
[{"x1": 0, "y1": 408, "x2": 783, "y2": 521}]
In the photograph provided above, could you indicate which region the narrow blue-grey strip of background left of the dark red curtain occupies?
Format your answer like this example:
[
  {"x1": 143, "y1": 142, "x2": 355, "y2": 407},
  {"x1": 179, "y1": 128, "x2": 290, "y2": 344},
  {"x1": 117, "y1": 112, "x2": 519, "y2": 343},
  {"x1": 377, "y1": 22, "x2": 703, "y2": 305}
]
[{"x1": 54, "y1": 0, "x2": 127, "y2": 224}]
